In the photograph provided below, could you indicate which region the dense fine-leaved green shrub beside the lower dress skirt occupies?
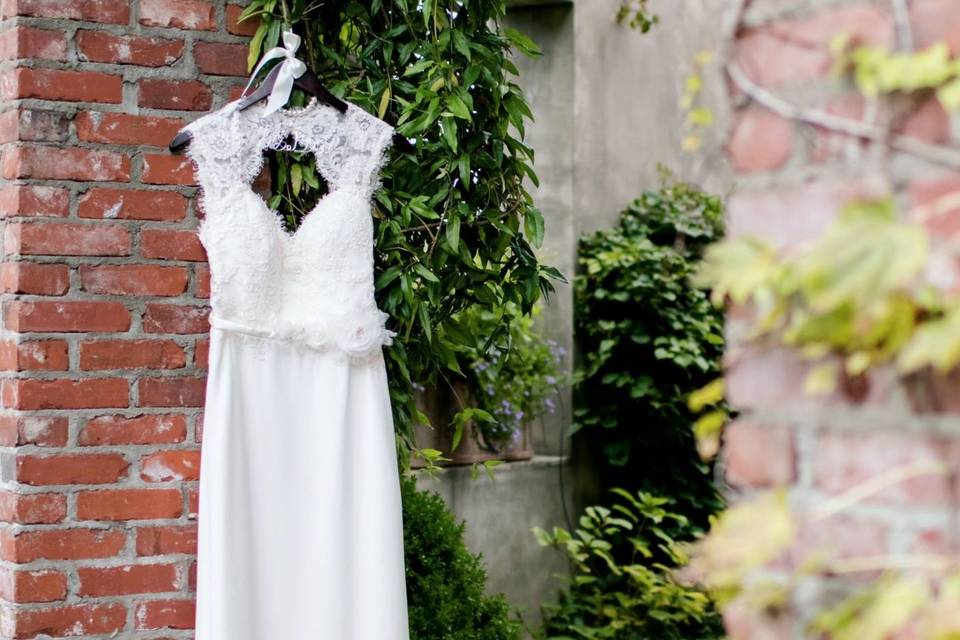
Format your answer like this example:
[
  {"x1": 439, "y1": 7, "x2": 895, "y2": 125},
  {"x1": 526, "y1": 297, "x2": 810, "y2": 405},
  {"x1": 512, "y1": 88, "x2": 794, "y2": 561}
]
[{"x1": 402, "y1": 476, "x2": 521, "y2": 640}]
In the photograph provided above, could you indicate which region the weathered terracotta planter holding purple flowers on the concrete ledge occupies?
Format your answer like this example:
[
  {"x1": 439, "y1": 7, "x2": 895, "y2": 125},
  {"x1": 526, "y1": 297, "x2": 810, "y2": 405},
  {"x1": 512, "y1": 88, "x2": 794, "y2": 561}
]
[{"x1": 411, "y1": 382, "x2": 533, "y2": 468}]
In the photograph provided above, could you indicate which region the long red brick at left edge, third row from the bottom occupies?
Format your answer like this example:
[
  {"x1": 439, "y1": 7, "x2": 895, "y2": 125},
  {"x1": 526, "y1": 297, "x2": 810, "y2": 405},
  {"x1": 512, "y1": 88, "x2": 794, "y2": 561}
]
[{"x1": 4, "y1": 528, "x2": 127, "y2": 563}]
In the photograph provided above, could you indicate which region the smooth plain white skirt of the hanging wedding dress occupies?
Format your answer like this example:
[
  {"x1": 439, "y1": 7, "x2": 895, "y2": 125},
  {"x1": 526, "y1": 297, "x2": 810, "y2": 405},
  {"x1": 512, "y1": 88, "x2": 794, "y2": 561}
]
[{"x1": 195, "y1": 327, "x2": 408, "y2": 640}]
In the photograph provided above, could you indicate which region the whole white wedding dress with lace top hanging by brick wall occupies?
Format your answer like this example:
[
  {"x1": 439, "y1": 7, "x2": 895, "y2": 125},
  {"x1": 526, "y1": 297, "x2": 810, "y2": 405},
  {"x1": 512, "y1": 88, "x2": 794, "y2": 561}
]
[{"x1": 188, "y1": 101, "x2": 408, "y2": 640}]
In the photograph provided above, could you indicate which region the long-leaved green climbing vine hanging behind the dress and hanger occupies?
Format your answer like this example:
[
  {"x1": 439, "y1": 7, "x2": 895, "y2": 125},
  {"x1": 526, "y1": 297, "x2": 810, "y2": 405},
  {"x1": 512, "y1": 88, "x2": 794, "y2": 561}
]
[{"x1": 242, "y1": 0, "x2": 561, "y2": 464}]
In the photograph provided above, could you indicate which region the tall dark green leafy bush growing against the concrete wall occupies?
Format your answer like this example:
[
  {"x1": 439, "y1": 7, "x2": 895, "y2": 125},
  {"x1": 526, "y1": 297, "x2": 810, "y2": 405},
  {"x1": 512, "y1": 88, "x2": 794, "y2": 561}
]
[{"x1": 575, "y1": 178, "x2": 723, "y2": 525}]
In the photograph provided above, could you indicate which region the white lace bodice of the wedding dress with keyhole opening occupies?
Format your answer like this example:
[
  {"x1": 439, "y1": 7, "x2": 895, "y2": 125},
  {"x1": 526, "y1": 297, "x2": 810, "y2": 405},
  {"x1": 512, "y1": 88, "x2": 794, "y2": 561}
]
[{"x1": 187, "y1": 100, "x2": 393, "y2": 357}]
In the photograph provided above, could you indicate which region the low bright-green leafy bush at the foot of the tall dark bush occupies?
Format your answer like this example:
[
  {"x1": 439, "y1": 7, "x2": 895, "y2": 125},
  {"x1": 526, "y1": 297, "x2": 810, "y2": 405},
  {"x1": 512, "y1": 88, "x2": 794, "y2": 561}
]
[{"x1": 534, "y1": 489, "x2": 723, "y2": 640}]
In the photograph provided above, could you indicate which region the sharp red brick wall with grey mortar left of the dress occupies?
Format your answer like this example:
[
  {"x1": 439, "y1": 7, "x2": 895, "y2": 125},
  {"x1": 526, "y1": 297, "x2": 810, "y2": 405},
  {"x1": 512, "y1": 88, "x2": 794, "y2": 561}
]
[{"x1": 0, "y1": 0, "x2": 251, "y2": 639}]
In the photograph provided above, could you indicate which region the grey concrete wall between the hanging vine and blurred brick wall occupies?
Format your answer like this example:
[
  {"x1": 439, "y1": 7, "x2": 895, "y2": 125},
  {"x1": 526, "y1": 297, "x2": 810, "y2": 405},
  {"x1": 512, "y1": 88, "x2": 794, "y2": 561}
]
[{"x1": 420, "y1": 0, "x2": 727, "y2": 624}]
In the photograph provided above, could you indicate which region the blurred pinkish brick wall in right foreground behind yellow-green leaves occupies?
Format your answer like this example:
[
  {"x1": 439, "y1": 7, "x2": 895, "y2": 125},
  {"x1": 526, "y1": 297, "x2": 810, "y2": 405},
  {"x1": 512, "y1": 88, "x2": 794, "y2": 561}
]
[{"x1": 723, "y1": 0, "x2": 960, "y2": 638}]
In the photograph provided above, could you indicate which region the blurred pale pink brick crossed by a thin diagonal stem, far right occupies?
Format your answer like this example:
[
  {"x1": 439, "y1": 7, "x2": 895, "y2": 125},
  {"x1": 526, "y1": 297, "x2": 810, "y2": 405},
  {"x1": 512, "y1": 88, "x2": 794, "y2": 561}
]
[{"x1": 813, "y1": 433, "x2": 952, "y2": 507}]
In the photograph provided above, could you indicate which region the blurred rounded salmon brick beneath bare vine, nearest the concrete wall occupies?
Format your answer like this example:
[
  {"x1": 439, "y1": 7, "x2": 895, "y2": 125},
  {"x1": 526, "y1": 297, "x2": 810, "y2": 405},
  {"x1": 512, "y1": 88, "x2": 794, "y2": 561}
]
[{"x1": 727, "y1": 107, "x2": 794, "y2": 173}]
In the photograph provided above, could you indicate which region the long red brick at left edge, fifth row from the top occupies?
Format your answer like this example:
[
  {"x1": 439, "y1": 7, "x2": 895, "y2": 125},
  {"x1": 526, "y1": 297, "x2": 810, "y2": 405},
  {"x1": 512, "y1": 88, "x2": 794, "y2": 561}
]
[{"x1": 2, "y1": 147, "x2": 131, "y2": 182}]
